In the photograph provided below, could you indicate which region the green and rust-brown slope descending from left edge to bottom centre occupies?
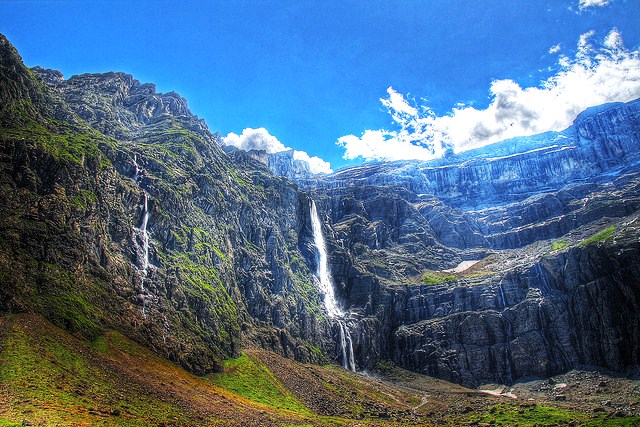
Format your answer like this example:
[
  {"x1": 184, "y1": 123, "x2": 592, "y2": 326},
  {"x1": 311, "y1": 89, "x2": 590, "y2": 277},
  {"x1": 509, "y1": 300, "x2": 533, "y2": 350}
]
[{"x1": 0, "y1": 315, "x2": 313, "y2": 426}]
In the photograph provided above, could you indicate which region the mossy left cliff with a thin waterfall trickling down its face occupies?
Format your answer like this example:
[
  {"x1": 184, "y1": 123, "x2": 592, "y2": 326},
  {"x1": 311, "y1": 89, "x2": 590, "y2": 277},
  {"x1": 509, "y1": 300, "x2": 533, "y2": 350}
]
[{"x1": 0, "y1": 34, "x2": 333, "y2": 373}]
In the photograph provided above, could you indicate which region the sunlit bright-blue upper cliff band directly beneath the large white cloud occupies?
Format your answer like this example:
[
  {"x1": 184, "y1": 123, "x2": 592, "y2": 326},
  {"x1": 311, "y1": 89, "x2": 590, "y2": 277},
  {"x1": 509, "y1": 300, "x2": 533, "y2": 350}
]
[{"x1": 301, "y1": 100, "x2": 640, "y2": 210}]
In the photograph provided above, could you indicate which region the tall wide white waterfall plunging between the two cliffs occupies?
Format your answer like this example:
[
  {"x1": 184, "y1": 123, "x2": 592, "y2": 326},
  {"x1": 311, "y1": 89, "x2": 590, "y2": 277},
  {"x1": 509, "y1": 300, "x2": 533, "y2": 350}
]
[{"x1": 311, "y1": 200, "x2": 356, "y2": 372}]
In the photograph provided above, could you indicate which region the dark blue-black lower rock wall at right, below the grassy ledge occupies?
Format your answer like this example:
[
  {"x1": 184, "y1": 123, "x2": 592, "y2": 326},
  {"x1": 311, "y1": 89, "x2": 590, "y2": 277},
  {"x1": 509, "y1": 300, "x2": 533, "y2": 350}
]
[{"x1": 393, "y1": 221, "x2": 640, "y2": 385}]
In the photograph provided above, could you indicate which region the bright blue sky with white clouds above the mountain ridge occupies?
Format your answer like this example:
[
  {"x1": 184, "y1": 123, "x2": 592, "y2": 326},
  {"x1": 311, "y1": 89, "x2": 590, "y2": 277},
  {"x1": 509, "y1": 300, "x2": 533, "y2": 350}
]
[{"x1": 0, "y1": 0, "x2": 640, "y2": 169}]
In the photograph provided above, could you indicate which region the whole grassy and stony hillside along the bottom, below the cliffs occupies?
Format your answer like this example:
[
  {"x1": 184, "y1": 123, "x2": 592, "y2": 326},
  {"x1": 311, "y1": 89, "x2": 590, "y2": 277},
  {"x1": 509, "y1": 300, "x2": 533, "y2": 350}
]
[{"x1": 0, "y1": 315, "x2": 640, "y2": 426}]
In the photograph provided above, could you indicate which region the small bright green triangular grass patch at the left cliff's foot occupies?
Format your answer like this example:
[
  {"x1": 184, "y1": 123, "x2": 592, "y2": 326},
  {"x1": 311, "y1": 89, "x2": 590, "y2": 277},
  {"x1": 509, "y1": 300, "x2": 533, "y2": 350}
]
[{"x1": 209, "y1": 353, "x2": 311, "y2": 414}]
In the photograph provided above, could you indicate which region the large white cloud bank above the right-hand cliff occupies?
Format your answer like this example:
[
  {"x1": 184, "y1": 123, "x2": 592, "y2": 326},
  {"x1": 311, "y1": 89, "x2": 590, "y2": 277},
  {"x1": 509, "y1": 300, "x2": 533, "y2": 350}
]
[{"x1": 337, "y1": 28, "x2": 640, "y2": 160}]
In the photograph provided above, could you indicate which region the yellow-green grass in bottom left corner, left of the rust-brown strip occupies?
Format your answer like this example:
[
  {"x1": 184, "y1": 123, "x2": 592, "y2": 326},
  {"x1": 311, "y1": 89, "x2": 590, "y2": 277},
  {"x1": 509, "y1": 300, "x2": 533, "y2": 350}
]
[{"x1": 0, "y1": 316, "x2": 192, "y2": 426}]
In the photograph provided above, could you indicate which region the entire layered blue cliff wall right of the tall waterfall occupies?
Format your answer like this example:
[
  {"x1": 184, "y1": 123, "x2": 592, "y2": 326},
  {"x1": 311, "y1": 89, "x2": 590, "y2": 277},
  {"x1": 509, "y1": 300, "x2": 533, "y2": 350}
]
[{"x1": 300, "y1": 101, "x2": 640, "y2": 385}]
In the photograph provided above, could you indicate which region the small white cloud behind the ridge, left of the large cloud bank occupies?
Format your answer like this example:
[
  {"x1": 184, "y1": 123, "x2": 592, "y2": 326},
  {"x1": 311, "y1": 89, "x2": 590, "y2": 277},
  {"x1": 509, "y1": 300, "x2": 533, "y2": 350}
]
[{"x1": 222, "y1": 128, "x2": 333, "y2": 174}]
